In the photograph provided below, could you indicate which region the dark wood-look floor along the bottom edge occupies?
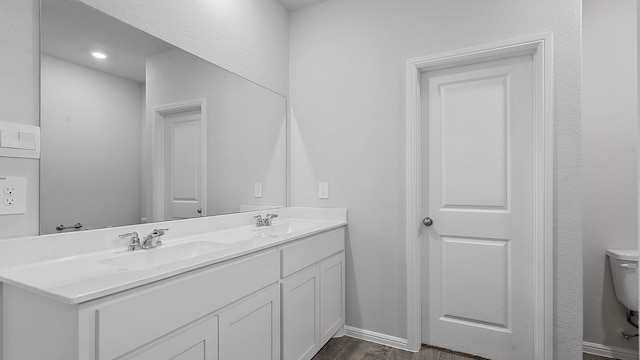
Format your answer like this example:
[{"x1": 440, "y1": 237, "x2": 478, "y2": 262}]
[{"x1": 313, "y1": 336, "x2": 609, "y2": 360}]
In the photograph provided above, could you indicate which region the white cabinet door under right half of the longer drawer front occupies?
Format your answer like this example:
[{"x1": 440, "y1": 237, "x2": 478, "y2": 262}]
[{"x1": 218, "y1": 285, "x2": 280, "y2": 360}]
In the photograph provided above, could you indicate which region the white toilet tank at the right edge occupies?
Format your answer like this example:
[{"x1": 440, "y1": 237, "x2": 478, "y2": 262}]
[{"x1": 607, "y1": 250, "x2": 638, "y2": 311}]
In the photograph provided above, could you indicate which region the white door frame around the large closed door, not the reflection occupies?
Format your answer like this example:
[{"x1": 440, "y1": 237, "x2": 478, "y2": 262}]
[{"x1": 405, "y1": 33, "x2": 554, "y2": 359}]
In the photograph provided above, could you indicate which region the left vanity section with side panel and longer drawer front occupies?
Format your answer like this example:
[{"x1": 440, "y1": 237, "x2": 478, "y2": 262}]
[{"x1": 2, "y1": 248, "x2": 280, "y2": 360}]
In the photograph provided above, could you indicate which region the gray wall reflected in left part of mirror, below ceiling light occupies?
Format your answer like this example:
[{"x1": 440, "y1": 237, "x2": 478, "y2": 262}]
[{"x1": 40, "y1": 55, "x2": 144, "y2": 234}]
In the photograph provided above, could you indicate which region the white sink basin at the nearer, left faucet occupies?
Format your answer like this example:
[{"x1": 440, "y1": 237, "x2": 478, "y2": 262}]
[{"x1": 99, "y1": 241, "x2": 232, "y2": 270}]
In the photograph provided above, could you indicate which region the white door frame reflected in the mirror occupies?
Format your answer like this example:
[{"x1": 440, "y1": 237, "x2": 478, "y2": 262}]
[{"x1": 151, "y1": 98, "x2": 207, "y2": 221}]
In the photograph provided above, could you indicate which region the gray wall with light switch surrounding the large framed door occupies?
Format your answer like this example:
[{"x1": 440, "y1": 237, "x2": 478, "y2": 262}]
[{"x1": 290, "y1": 0, "x2": 582, "y2": 360}]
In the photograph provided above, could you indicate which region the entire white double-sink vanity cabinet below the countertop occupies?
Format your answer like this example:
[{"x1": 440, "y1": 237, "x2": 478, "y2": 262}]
[{"x1": 0, "y1": 222, "x2": 345, "y2": 360}]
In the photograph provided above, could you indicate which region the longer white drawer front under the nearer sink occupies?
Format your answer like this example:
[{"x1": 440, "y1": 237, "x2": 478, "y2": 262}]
[{"x1": 96, "y1": 249, "x2": 278, "y2": 360}]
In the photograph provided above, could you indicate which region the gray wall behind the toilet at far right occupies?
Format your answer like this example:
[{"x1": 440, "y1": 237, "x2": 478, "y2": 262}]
[{"x1": 582, "y1": 0, "x2": 638, "y2": 352}]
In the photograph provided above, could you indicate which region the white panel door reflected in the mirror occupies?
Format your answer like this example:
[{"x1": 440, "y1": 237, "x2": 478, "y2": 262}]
[{"x1": 164, "y1": 110, "x2": 203, "y2": 220}]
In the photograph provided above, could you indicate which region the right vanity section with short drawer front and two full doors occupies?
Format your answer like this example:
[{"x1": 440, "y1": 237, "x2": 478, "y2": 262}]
[{"x1": 280, "y1": 228, "x2": 344, "y2": 360}]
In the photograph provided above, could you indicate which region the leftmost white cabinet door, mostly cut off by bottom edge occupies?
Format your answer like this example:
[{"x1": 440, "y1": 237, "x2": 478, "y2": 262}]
[{"x1": 123, "y1": 316, "x2": 218, "y2": 360}]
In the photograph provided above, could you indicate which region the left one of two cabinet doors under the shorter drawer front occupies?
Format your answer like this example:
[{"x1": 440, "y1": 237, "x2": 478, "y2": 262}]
[{"x1": 282, "y1": 265, "x2": 320, "y2": 360}]
